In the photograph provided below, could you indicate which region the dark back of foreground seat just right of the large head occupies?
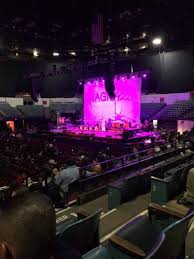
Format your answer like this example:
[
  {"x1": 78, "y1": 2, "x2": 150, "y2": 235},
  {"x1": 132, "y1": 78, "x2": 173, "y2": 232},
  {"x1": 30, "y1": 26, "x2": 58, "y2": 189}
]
[{"x1": 59, "y1": 209, "x2": 102, "y2": 254}]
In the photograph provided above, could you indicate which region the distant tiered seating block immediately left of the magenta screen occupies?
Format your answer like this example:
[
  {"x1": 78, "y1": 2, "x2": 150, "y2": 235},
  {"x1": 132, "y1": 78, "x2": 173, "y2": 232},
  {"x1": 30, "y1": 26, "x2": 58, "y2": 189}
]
[{"x1": 50, "y1": 102, "x2": 80, "y2": 113}]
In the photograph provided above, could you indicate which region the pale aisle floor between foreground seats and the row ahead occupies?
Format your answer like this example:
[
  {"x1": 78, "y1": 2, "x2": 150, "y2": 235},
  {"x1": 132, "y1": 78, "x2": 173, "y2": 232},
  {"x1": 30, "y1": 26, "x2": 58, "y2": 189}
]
[{"x1": 56, "y1": 194, "x2": 150, "y2": 242}]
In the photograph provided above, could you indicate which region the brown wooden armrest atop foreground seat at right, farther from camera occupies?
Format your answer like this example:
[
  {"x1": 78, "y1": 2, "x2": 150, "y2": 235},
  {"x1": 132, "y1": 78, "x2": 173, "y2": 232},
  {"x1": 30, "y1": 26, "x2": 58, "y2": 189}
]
[{"x1": 148, "y1": 203, "x2": 185, "y2": 219}]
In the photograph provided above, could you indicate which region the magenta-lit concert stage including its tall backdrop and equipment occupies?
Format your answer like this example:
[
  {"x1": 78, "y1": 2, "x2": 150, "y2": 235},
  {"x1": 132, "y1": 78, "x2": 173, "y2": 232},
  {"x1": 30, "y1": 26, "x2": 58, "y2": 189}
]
[{"x1": 51, "y1": 72, "x2": 153, "y2": 142}]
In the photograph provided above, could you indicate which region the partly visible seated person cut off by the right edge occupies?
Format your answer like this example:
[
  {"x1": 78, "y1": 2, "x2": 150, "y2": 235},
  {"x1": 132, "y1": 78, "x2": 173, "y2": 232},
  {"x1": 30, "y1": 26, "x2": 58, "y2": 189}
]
[{"x1": 177, "y1": 168, "x2": 194, "y2": 204}]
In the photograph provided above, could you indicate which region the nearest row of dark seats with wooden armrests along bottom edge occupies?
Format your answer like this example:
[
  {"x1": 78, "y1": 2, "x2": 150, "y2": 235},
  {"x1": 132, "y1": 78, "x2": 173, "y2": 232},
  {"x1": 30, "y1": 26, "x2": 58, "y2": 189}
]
[{"x1": 53, "y1": 203, "x2": 194, "y2": 259}]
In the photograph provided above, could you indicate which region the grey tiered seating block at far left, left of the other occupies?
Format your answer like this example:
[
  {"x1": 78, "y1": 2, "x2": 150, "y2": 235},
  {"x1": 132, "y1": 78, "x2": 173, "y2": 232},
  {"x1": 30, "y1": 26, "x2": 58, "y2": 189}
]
[{"x1": 17, "y1": 105, "x2": 44, "y2": 118}]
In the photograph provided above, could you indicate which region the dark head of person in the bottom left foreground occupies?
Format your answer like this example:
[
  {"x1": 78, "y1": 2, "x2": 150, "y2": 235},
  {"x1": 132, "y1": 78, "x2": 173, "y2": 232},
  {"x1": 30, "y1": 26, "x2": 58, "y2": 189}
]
[{"x1": 0, "y1": 192, "x2": 56, "y2": 259}]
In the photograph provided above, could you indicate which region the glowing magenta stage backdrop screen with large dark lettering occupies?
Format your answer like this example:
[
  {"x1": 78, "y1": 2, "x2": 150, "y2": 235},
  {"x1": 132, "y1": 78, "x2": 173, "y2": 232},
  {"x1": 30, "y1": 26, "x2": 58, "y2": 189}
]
[{"x1": 84, "y1": 76, "x2": 141, "y2": 125}]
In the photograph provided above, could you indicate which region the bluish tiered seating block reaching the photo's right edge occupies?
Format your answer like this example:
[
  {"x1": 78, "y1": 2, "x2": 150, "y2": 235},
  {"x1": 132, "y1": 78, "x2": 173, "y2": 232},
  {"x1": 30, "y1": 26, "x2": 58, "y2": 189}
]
[{"x1": 153, "y1": 100, "x2": 194, "y2": 120}]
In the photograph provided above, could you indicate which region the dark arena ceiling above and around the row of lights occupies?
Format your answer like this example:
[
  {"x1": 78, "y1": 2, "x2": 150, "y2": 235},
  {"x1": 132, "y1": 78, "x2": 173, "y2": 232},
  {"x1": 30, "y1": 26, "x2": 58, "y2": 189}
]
[{"x1": 0, "y1": 0, "x2": 194, "y2": 60}]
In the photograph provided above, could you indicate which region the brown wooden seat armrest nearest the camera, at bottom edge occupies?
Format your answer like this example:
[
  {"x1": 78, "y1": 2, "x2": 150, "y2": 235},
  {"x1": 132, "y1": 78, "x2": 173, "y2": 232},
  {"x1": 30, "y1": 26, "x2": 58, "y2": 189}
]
[{"x1": 109, "y1": 235, "x2": 145, "y2": 258}]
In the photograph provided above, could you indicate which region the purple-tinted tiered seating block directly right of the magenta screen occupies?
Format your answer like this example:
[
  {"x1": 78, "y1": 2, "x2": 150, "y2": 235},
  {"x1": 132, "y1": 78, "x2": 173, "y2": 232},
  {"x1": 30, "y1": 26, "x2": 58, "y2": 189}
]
[{"x1": 141, "y1": 103, "x2": 166, "y2": 120}]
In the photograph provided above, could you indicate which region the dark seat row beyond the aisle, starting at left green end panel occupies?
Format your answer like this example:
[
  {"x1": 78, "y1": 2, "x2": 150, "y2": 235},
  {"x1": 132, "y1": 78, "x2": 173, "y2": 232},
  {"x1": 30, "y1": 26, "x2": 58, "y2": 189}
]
[{"x1": 108, "y1": 153, "x2": 194, "y2": 209}]
